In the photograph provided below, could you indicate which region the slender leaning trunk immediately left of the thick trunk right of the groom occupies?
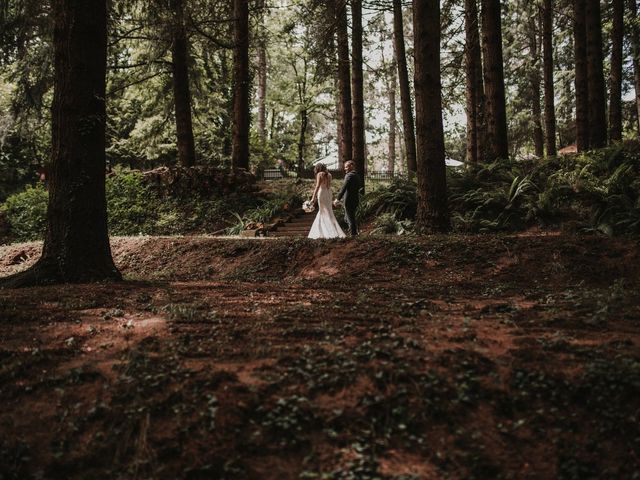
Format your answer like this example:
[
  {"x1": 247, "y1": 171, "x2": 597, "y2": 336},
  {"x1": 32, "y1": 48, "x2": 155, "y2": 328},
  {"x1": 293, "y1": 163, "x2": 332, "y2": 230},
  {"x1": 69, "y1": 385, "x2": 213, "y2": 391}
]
[{"x1": 393, "y1": 0, "x2": 417, "y2": 175}]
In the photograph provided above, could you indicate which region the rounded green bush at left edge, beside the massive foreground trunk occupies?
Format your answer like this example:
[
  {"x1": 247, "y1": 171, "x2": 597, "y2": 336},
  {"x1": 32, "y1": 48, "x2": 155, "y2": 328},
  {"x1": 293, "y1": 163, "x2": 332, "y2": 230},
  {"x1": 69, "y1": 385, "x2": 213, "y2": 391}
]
[{"x1": 0, "y1": 185, "x2": 48, "y2": 241}]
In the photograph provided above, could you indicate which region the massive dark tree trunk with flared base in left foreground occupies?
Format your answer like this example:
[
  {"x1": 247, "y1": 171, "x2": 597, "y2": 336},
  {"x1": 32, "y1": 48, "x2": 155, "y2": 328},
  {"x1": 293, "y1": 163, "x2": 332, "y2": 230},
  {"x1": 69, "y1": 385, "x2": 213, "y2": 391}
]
[{"x1": 2, "y1": 0, "x2": 121, "y2": 287}]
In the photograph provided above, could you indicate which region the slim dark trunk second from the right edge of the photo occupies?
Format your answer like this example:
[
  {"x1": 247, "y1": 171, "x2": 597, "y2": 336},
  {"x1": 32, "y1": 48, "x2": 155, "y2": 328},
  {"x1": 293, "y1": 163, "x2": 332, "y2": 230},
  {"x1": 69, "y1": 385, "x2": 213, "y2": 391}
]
[{"x1": 609, "y1": 0, "x2": 624, "y2": 142}]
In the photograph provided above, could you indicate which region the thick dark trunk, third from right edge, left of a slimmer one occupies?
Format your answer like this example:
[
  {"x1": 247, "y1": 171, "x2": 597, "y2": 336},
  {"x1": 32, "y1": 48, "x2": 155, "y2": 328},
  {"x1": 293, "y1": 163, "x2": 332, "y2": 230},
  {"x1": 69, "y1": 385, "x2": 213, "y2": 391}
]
[{"x1": 586, "y1": 0, "x2": 607, "y2": 148}]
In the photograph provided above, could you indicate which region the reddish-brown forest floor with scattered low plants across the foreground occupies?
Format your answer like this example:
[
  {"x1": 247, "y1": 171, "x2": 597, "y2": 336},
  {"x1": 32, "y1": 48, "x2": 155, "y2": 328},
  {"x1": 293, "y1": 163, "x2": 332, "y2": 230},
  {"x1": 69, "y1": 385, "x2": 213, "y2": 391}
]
[{"x1": 0, "y1": 232, "x2": 640, "y2": 480}]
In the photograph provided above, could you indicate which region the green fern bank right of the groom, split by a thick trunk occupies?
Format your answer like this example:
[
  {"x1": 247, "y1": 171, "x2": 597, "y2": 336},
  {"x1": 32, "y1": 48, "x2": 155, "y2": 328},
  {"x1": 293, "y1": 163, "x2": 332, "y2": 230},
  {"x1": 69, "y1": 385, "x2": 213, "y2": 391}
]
[{"x1": 359, "y1": 143, "x2": 640, "y2": 235}]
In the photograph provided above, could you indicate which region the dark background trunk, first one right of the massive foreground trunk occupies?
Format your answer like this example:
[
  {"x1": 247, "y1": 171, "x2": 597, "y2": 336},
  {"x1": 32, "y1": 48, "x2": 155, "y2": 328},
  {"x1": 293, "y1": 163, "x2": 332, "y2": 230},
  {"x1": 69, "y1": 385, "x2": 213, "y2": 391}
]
[{"x1": 171, "y1": 0, "x2": 196, "y2": 167}]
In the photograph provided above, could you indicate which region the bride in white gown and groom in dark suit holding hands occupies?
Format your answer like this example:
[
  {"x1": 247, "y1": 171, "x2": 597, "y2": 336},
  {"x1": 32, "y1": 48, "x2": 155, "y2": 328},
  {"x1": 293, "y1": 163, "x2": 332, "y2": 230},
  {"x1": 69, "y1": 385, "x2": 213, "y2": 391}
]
[{"x1": 309, "y1": 160, "x2": 362, "y2": 238}]
